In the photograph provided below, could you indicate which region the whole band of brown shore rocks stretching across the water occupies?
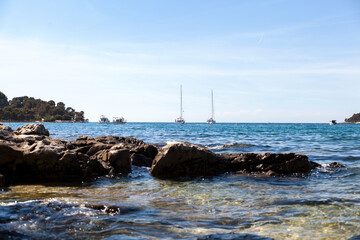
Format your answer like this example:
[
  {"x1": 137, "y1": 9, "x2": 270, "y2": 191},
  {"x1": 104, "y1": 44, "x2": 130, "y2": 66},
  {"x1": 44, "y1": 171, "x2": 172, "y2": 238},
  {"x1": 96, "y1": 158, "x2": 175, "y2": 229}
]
[{"x1": 0, "y1": 123, "x2": 342, "y2": 186}]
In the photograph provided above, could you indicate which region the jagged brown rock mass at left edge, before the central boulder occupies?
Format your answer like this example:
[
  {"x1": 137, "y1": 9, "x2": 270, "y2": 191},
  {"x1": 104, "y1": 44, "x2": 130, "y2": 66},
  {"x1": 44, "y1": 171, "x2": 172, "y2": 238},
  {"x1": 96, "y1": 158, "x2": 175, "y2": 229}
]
[{"x1": 0, "y1": 124, "x2": 149, "y2": 186}]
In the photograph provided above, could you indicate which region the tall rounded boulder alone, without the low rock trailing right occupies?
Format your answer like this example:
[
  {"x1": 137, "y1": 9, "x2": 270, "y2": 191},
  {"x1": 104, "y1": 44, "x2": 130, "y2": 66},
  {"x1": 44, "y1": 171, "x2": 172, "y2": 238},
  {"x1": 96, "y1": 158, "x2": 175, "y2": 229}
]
[{"x1": 150, "y1": 143, "x2": 225, "y2": 178}]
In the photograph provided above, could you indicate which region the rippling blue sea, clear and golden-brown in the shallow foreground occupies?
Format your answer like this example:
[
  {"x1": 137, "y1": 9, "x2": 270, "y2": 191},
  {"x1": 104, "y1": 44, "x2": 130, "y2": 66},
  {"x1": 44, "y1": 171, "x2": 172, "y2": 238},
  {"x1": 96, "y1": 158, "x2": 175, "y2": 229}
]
[{"x1": 0, "y1": 123, "x2": 360, "y2": 240}]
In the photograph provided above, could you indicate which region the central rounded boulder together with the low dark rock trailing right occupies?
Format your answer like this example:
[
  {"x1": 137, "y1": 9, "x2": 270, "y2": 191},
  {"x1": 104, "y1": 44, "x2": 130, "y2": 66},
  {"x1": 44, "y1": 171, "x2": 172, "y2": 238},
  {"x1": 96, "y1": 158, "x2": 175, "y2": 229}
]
[{"x1": 150, "y1": 143, "x2": 330, "y2": 178}]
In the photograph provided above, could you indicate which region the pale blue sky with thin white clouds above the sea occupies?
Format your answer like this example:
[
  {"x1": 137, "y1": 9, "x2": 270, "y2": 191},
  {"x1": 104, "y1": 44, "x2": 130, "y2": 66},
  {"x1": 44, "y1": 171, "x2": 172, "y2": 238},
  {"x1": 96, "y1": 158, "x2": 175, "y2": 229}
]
[{"x1": 0, "y1": 0, "x2": 360, "y2": 123}]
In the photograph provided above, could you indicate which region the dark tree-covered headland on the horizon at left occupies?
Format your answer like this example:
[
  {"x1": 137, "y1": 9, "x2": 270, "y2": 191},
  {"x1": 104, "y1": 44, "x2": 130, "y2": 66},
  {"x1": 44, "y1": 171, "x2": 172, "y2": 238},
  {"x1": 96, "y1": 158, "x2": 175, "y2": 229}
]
[{"x1": 0, "y1": 91, "x2": 85, "y2": 122}]
